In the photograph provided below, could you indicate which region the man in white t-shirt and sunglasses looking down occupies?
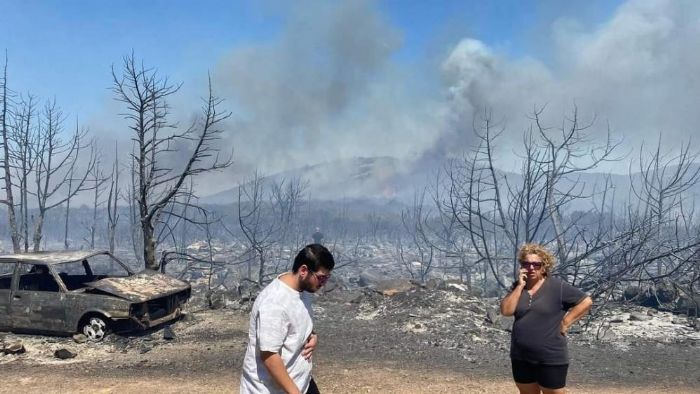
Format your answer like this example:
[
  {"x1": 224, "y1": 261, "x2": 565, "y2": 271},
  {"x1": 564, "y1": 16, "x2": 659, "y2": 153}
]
[{"x1": 240, "y1": 244, "x2": 335, "y2": 394}]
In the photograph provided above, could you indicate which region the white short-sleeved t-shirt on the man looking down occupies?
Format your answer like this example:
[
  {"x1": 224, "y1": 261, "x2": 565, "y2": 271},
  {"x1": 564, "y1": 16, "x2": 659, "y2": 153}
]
[{"x1": 240, "y1": 274, "x2": 313, "y2": 394}]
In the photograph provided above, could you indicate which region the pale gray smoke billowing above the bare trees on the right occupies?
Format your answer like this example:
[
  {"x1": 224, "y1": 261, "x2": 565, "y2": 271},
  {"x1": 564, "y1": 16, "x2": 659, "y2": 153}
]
[{"x1": 434, "y1": 0, "x2": 700, "y2": 172}]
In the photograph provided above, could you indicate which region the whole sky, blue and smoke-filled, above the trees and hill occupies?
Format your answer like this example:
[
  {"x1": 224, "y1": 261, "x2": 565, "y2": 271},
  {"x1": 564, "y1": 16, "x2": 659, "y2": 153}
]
[{"x1": 0, "y1": 0, "x2": 700, "y2": 196}]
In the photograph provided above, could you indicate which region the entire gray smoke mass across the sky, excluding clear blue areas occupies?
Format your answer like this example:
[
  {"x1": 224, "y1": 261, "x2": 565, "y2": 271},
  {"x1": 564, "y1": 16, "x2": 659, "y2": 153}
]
[{"x1": 94, "y1": 0, "x2": 700, "y2": 195}]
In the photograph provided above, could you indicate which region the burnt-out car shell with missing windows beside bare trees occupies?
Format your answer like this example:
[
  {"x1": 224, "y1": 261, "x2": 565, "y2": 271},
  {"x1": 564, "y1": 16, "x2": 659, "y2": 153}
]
[{"x1": 0, "y1": 251, "x2": 191, "y2": 341}]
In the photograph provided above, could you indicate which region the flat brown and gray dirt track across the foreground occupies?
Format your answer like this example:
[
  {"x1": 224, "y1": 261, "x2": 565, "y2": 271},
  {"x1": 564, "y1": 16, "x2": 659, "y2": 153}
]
[{"x1": 0, "y1": 294, "x2": 700, "y2": 394}]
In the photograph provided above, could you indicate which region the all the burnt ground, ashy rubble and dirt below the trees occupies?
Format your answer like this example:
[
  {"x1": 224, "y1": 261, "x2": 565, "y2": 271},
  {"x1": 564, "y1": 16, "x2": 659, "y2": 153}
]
[{"x1": 0, "y1": 280, "x2": 700, "y2": 393}]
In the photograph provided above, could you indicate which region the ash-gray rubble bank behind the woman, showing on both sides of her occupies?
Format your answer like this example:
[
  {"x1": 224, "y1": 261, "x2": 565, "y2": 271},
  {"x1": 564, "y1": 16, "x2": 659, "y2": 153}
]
[{"x1": 315, "y1": 281, "x2": 700, "y2": 354}]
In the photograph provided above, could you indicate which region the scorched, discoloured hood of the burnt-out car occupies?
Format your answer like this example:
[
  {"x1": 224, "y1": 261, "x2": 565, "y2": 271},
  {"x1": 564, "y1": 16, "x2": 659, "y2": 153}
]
[{"x1": 85, "y1": 271, "x2": 190, "y2": 302}]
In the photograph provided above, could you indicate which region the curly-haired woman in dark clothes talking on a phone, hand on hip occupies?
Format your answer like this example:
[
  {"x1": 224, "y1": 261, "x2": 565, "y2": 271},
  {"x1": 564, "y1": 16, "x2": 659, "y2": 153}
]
[{"x1": 501, "y1": 244, "x2": 593, "y2": 394}]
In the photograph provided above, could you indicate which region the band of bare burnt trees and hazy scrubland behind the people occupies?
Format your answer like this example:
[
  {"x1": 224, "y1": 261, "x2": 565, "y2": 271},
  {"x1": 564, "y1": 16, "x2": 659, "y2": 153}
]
[{"x1": 0, "y1": 54, "x2": 700, "y2": 324}]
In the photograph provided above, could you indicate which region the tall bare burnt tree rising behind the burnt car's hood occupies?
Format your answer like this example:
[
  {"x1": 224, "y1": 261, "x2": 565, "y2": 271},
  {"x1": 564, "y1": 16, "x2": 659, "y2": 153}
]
[{"x1": 112, "y1": 54, "x2": 232, "y2": 270}]
